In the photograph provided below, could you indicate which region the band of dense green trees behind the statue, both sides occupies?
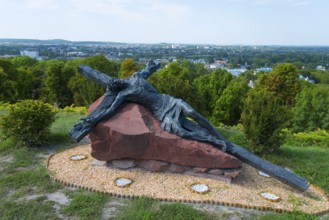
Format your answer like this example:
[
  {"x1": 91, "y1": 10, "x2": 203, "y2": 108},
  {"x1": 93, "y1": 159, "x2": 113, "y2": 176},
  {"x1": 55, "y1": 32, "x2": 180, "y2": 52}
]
[{"x1": 0, "y1": 55, "x2": 329, "y2": 152}]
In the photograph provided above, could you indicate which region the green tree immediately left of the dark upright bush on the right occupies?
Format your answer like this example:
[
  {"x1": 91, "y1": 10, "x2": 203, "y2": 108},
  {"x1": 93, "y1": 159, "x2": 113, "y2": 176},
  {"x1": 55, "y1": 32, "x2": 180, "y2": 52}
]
[{"x1": 213, "y1": 78, "x2": 250, "y2": 125}]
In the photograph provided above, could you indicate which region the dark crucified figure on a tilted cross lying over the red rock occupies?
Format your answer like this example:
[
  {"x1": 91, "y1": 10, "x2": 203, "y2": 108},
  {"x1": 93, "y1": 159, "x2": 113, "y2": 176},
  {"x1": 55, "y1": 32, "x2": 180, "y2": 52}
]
[{"x1": 69, "y1": 61, "x2": 309, "y2": 190}]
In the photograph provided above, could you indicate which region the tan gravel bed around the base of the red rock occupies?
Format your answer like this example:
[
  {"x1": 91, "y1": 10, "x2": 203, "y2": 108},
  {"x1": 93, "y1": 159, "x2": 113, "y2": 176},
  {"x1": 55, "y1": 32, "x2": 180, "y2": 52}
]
[{"x1": 48, "y1": 145, "x2": 329, "y2": 214}]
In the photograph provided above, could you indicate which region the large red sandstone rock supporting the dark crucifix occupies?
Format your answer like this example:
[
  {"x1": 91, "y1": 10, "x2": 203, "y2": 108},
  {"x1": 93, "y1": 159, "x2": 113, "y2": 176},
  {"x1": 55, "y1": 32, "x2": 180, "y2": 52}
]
[{"x1": 89, "y1": 99, "x2": 241, "y2": 168}]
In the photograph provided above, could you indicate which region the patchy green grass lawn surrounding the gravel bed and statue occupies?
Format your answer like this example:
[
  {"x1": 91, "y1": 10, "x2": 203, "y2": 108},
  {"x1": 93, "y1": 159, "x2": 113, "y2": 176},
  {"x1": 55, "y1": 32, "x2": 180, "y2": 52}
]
[{"x1": 0, "y1": 112, "x2": 329, "y2": 219}]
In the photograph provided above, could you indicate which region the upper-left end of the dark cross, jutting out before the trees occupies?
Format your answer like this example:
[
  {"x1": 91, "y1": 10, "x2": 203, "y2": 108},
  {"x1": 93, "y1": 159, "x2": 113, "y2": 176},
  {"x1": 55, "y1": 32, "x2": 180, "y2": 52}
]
[{"x1": 78, "y1": 65, "x2": 113, "y2": 87}]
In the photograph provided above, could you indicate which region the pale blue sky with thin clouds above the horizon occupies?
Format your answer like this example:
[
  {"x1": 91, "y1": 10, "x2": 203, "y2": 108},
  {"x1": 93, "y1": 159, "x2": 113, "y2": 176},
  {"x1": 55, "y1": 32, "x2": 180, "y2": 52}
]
[{"x1": 0, "y1": 0, "x2": 329, "y2": 46}]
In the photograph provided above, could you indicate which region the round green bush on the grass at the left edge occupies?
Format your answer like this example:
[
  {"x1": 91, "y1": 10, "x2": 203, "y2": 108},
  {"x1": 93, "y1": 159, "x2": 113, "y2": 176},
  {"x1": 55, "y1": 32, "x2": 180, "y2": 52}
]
[{"x1": 0, "y1": 100, "x2": 56, "y2": 147}]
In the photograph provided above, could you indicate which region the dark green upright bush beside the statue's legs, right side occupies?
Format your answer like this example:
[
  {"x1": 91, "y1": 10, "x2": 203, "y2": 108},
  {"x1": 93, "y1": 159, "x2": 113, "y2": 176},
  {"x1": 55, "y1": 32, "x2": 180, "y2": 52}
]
[{"x1": 242, "y1": 90, "x2": 288, "y2": 154}]
